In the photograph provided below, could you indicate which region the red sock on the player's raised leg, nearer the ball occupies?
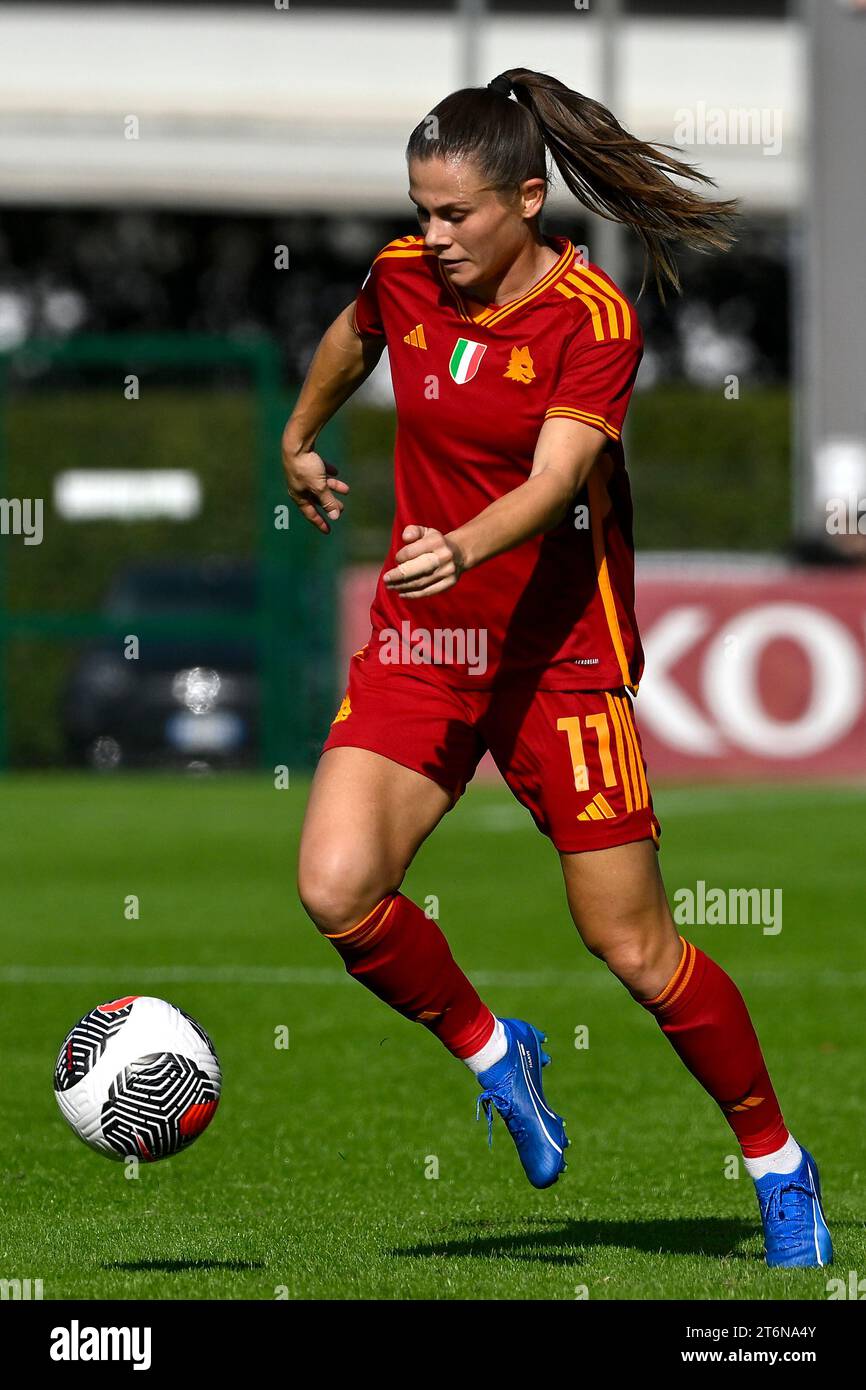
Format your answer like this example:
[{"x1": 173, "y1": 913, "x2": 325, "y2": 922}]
[{"x1": 322, "y1": 892, "x2": 496, "y2": 1058}]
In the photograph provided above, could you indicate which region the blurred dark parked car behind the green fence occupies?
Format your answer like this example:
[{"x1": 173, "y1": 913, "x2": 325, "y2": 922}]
[{"x1": 61, "y1": 560, "x2": 260, "y2": 770}]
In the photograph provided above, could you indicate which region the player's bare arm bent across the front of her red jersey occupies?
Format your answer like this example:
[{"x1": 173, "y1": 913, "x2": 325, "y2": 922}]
[{"x1": 385, "y1": 418, "x2": 606, "y2": 599}]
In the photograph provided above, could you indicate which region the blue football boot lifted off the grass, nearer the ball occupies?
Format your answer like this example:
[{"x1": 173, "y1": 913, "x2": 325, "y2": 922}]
[{"x1": 475, "y1": 1019, "x2": 569, "y2": 1187}]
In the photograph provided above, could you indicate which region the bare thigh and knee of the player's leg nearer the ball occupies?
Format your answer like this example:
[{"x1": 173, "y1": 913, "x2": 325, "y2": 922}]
[{"x1": 297, "y1": 748, "x2": 452, "y2": 931}]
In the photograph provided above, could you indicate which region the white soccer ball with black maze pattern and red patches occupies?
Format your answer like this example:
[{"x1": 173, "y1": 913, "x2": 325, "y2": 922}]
[{"x1": 54, "y1": 994, "x2": 222, "y2": 1163}]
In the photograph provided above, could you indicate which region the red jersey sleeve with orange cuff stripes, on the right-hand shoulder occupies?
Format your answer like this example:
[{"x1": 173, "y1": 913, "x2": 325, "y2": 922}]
[{"x1": 545, "y1": 318, "x2": 644, "y2": 439}]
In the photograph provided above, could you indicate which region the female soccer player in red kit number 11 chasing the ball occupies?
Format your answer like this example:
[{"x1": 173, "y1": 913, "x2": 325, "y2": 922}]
[{"x1": 284, "y1": 68, "x2": 833, "y2": 1265}]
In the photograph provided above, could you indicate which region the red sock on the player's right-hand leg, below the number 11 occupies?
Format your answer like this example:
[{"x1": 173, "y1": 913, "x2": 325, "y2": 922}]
[{"x1": 639, "y1": 937, "x2": 788, "y2": 1158}]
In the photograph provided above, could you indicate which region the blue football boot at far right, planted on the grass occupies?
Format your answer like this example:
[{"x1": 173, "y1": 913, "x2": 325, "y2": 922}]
[{"x1": 755, "y1": 1145, "x2": 833, "y2": 1268}]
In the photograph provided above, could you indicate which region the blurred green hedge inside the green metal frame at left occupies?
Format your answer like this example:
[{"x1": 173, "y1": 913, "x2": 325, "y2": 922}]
[{"x1": 0, "y1": 388, "x2": 259, "y2": 766}]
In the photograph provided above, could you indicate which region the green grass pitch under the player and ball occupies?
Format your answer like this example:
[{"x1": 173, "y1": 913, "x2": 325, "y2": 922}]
[{"x1": 0, "y1": 774, "x2": 866, "y2": 1300}]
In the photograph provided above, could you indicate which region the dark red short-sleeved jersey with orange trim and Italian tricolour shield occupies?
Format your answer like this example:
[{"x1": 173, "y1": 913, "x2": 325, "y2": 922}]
[{"x1": 354, "y1": 235, "x2": 644, "y2": 691}]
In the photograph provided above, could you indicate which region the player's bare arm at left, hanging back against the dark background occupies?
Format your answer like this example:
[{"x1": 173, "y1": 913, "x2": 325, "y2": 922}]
[{"x1": 282, "y1": 303, "x2": 384, "y2": 535}]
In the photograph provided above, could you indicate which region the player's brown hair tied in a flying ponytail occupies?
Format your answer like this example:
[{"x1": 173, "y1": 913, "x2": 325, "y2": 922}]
[{"x1": 406, "y1": 68, "x2": 737, "y2": 303}]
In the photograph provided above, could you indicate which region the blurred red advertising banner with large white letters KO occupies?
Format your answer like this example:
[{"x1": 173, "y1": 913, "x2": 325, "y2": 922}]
[{"x1": 342, "y1": 557, "x2": 866, "y2": 781}]
